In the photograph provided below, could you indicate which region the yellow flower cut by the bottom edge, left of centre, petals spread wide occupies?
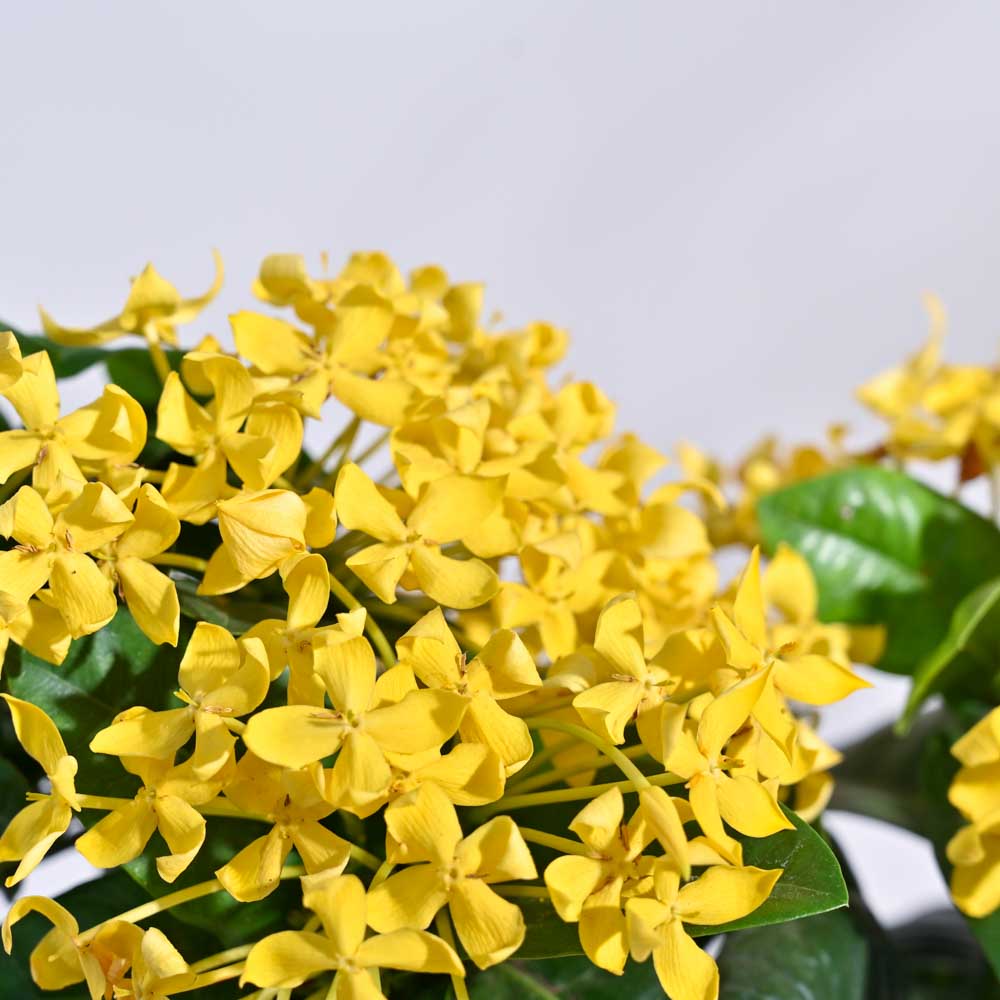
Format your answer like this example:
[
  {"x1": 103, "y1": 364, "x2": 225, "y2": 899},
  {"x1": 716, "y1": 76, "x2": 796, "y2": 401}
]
[{"x1": 240, "y1": 872, "x2": 465, "y2": 1000}]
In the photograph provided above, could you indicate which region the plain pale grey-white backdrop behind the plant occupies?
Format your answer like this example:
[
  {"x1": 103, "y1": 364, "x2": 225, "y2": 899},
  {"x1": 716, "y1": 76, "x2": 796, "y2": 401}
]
[{"x1": 0, "y1": 0, "x2": 1000, "y2": 922}]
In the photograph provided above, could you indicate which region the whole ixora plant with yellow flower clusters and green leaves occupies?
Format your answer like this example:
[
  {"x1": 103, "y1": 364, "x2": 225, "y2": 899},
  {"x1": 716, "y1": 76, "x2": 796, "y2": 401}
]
[{"x1": 0, "y1": 254, "x2": 976, "y2": 1000}]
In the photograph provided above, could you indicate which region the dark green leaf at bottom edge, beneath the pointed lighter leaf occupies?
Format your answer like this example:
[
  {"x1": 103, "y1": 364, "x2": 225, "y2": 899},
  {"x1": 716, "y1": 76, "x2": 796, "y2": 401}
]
[{"x1": 719, "y1": 910, "x2": 869, "y2": 1000}]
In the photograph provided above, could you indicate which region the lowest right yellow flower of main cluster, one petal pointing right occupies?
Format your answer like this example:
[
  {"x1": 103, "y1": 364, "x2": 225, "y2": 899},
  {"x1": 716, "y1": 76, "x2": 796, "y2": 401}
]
[{"x1": 625, "y1": 865, "x2": 782, "y2": 1000}]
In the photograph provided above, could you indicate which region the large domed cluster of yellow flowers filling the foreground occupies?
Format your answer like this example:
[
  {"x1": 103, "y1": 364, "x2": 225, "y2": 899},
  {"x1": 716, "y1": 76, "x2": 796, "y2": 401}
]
[{"x1": 0, "y1": 253, "x2": 865, "y2": 1000}]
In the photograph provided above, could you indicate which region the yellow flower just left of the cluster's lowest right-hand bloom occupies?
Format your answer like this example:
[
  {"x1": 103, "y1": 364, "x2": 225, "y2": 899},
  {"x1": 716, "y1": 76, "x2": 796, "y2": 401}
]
[{"x1": 545, "y1": 789, "x2": 654, "y2": 975}]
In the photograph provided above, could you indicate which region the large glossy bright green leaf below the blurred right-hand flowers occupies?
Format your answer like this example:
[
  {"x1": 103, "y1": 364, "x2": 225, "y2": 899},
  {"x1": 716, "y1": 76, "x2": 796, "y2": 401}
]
[{"x1": 757, "y1": 466, "x2": 1000, "y2": 673}]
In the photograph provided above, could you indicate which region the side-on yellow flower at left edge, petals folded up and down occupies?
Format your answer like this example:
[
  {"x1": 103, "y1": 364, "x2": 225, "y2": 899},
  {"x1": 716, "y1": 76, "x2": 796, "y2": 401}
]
[{"x1": 0, "y1": 694, "x2": 80, "y2": 888}]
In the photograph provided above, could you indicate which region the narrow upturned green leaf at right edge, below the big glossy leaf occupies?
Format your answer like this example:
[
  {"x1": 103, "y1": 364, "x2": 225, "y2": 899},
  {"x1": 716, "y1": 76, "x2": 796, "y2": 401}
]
[{"x1": 900, "y1": 578, "x2": 1000, "y2": 727}]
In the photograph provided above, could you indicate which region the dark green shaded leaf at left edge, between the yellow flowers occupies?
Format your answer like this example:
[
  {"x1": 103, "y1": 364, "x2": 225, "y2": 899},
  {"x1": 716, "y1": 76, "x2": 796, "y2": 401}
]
[{"x1": 3, "y1": 607, "x2": 184, "y2": 795}]
